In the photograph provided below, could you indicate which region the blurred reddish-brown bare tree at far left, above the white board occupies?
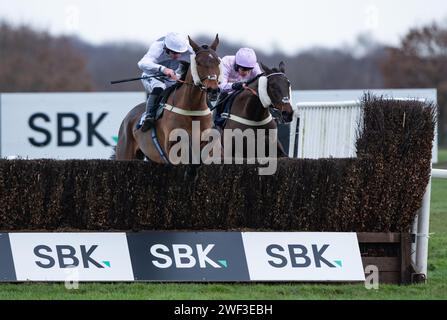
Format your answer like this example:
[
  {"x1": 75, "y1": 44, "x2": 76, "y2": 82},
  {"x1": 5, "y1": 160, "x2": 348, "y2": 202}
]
[{"x1": 0, "y1": 23, "x2": 93, "y2": 92}]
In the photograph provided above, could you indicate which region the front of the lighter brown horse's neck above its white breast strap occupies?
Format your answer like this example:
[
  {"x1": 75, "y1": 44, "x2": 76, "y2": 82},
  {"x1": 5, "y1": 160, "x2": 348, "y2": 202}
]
[{"x1": 171, "y1": 68, "x2": 208, "y2": 110}]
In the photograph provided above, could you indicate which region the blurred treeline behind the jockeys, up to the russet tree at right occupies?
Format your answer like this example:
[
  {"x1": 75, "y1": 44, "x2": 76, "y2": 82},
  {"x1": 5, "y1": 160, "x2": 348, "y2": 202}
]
[{"x1": 0, "y1": 23, "x2": 384, "y2": 92}]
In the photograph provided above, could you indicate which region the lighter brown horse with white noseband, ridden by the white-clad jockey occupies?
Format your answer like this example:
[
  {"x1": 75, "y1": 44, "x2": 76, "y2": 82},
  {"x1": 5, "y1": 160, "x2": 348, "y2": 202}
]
[{"x1": 115, "y1": 35, "x2": 220, "y2": 163}]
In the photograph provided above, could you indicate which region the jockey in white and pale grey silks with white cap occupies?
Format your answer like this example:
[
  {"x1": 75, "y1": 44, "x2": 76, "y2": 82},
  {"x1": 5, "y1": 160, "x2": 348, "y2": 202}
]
[{"x1": 138, "y1": 32, "x2": 193, "y2": 132}]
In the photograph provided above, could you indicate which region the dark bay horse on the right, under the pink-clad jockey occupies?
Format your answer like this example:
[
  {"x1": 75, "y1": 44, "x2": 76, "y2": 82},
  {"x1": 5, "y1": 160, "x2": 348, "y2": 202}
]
[{"x1": 222, "y1": 61, "x2": 293, "y2": 157}]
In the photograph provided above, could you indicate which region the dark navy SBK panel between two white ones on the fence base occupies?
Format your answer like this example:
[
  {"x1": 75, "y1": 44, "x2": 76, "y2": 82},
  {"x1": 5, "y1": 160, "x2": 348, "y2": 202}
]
[{"x1": 127, "y1": 232, "x2": 250, "y2": 281}]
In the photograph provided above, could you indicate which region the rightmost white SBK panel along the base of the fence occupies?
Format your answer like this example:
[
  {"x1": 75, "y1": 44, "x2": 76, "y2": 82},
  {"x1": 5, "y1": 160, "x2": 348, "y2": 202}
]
[{"x1": 242, "y1": 232, "x2": 365, "y2": 281}]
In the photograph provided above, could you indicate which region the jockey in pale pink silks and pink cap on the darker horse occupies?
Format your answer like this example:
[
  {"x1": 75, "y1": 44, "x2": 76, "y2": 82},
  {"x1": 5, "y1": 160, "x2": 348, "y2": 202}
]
[{"x1": 215, "y1": 48, "x2": 262, "y2": 126}]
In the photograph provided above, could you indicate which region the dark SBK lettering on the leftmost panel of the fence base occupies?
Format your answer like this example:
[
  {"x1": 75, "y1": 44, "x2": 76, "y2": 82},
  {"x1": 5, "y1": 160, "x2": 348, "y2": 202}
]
[{"x1": 34, "y1": 245, "x2": 111, "y2": 269}]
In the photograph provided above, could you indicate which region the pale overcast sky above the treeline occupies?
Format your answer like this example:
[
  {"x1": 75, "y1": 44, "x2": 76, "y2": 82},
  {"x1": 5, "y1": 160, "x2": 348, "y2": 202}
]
[{"x1": 0, "y1": 0, "x2": 447, "y2": 54}]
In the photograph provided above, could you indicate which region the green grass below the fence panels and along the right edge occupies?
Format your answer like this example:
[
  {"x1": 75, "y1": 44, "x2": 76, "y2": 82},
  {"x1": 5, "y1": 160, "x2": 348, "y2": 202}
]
[{"x1": 0, "y1": 154, "x2": 447, "y2": 300}]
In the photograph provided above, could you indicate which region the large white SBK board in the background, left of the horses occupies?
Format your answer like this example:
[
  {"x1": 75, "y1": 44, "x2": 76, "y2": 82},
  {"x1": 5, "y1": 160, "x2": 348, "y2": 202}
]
[{"x1": 0, "y1": 92, "x2": 145, "y2": 160}]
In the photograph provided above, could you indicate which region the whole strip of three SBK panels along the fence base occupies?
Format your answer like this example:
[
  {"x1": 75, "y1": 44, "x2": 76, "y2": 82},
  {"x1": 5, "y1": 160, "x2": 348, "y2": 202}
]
[{"x1": 0, "y1": 231, "x2": 365, "y2": 282}]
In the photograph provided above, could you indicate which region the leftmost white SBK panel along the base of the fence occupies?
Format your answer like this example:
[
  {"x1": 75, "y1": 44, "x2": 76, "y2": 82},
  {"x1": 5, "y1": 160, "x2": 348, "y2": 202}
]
[{"x1": 9, "y1": 232, "x2": 133, "y2": 281}]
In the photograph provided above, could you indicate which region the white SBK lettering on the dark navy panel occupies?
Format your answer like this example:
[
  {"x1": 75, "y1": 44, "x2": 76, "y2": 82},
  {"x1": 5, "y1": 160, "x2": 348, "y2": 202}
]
[{"x1": 150, "y1": 244, "x2": 228, "y2": 269}]
